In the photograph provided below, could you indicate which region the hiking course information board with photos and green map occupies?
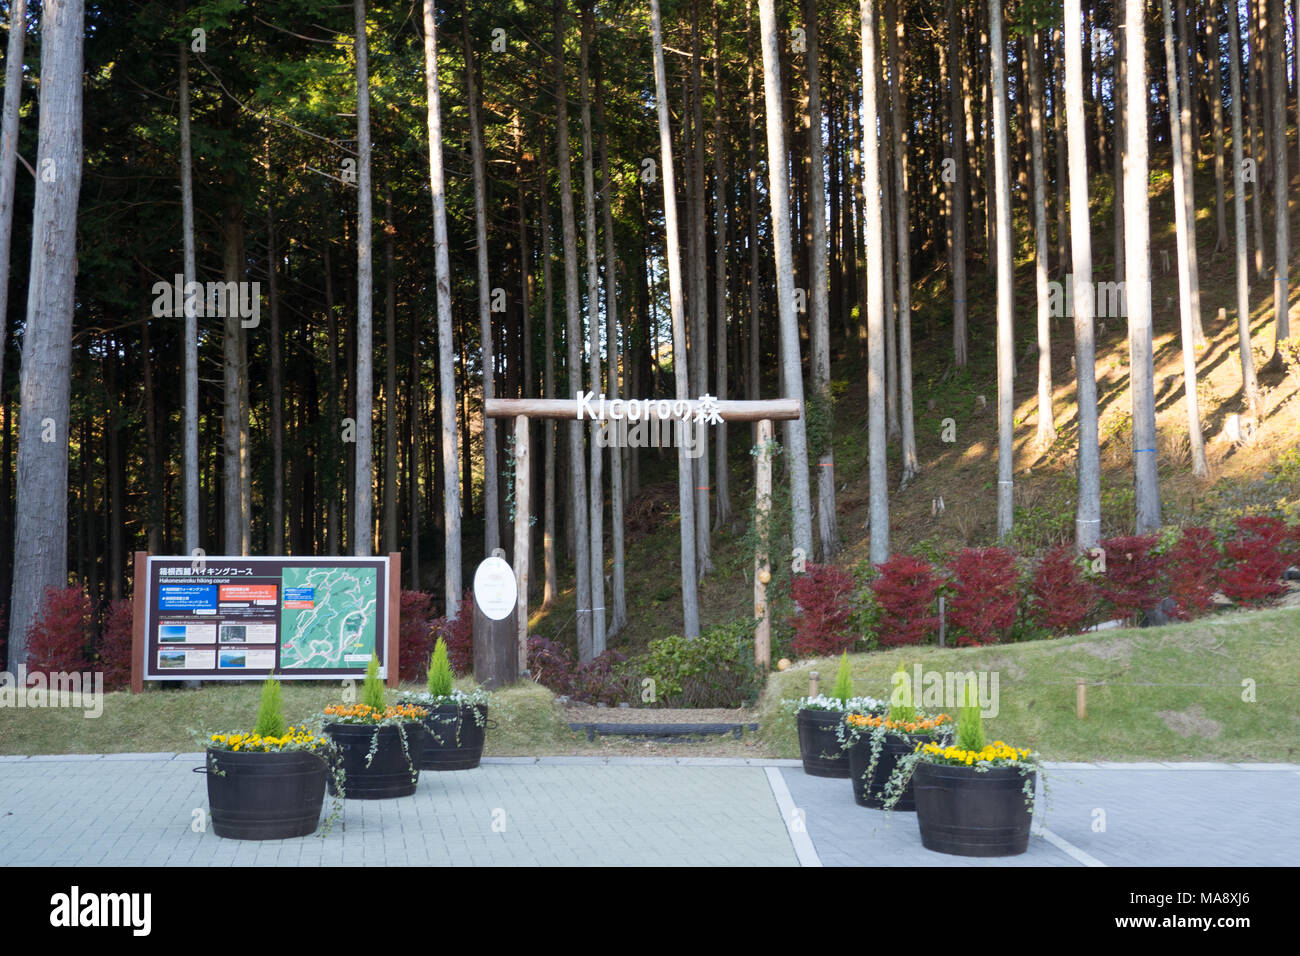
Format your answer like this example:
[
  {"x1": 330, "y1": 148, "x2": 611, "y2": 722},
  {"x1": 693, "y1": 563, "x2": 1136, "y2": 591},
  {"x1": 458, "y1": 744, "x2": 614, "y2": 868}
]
[{"x1": 143, "y1": 557, "x2": 390, "y2": 680}]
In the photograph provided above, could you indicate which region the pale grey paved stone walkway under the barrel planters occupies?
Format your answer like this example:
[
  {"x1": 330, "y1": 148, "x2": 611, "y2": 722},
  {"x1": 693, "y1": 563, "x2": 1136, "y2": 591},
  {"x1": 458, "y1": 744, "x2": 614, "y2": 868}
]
[{"x1": 0, "y1": 753, "x2": 1300, "y2": 866}]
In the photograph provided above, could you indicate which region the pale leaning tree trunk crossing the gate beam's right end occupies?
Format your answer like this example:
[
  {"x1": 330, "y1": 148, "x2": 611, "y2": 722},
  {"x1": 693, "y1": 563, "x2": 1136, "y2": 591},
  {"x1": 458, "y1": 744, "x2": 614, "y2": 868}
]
[{"x1": 758, "y1": 0, "x2": 811, "y2": 555}]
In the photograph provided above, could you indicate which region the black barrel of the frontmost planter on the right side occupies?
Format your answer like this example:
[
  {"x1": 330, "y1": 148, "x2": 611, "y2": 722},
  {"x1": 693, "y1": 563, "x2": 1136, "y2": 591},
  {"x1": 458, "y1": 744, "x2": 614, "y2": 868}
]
[{"x1": 911, "y1": 761, "x2": 1037, "y2": 856}]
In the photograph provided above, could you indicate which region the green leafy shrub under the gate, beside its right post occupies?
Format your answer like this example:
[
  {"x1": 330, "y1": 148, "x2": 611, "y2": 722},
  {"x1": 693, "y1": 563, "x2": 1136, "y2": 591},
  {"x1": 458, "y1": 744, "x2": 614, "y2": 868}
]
[{"x1": 637, "y1": 619, "x2": 763, "y2": 708}]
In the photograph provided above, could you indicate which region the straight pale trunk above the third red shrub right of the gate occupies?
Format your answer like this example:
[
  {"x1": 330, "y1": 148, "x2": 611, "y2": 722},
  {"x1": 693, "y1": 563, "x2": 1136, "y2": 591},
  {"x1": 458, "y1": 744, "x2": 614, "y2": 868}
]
[{"x1": 988, "y1": 0, "x2": 1015, "y2": 538}]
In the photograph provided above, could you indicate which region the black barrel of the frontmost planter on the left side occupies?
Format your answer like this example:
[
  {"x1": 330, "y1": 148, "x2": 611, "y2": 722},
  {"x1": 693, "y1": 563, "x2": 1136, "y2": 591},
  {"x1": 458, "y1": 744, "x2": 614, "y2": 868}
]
[{"x1": 204, "y1": 750, "x2": 328, "y2": 840}]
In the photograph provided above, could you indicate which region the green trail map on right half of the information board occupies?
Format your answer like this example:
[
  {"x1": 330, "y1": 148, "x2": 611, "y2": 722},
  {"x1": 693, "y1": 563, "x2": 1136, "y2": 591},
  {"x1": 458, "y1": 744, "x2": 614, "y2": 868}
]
[{"x1": 280, "y1": 566, "x2": 378, "y2": 670}]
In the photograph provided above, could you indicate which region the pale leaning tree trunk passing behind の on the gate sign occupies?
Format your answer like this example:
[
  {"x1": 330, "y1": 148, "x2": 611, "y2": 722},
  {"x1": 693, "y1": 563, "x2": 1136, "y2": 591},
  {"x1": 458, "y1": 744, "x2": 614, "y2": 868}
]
[{"x1": 650, "y1": 0, "x2": 702, "y2": 637}]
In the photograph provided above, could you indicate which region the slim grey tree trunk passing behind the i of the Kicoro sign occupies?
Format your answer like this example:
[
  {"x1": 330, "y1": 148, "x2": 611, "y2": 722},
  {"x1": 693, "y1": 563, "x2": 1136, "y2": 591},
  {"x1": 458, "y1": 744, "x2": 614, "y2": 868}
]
[{"x1": 579, "y1": 3, "x2": 603, "y2": 657}]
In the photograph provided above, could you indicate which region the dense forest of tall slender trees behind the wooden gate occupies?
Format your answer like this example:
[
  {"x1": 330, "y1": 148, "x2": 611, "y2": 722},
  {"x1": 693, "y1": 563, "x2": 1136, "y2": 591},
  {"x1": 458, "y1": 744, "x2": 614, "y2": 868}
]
[{"x1": 0, "y1": 0, "x2": 1300, "y2": 670}]
